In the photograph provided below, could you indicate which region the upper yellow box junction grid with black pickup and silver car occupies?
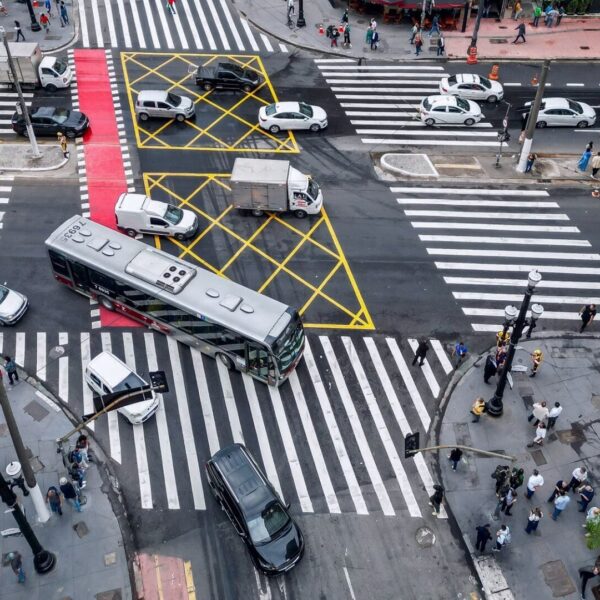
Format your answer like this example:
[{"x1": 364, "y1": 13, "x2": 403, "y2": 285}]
[{"x1": 121, "y1": 52, "x2": 300, "y2": 153}]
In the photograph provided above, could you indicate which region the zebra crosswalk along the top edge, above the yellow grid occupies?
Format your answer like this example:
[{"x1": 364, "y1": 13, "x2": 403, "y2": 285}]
[{"x1": 77, "y1": 0, "x2": 288, "y2": 52}]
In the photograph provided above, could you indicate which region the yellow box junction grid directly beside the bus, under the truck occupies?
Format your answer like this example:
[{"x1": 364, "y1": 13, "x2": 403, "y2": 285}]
[{"x1": 144, "y1": 173, "x2": 375, "y2": 330}]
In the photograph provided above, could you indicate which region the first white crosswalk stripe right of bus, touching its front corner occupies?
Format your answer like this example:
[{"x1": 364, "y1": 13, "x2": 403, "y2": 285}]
[{"x1": 304, "y1": 340, "x2": 369, "y2": 515}]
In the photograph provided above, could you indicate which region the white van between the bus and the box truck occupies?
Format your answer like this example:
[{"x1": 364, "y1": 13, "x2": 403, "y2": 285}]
[{"x1": 115, "y1": 193, "x2": 198, "y2": 240}]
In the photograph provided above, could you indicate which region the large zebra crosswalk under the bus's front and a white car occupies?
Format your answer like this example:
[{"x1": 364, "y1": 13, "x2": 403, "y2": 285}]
[{"x1": 0, "y1": 331, "x2": 452, "y2": 518}]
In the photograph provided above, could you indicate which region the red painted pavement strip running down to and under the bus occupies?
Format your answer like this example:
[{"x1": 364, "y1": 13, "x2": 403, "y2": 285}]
[{"x1": 75, "y1": 50, "x2": 139, "y2": 327}]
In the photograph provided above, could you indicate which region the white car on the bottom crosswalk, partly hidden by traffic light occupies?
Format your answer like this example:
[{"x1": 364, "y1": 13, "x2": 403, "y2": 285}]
[{"x1": 84, "y1": 352, "x2": 159, "y2": 425}]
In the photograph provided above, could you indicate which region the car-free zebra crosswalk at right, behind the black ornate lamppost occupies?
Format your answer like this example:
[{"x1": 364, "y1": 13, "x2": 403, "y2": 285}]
[{"x1": 390, "y1": 186, "x2": 600, "y2": 331}]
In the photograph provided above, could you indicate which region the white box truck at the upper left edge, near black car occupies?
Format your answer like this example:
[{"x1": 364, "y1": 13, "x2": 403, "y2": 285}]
[{"x1": 0, "y1": 42, "x2": 73, "y2": 92}]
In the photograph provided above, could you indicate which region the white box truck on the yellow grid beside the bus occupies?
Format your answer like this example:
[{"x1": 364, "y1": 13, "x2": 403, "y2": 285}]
[{"x1": 231, "y1": 158, "x2": 323, "y2": 218}]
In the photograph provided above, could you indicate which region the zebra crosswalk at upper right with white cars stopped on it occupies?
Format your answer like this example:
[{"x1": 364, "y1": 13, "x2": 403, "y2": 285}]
[{"x1": 315, "y1": 58, "x2": 498, "y2": 148}]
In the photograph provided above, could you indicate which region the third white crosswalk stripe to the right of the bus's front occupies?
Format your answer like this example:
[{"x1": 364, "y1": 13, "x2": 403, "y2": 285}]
[{"x1": 342, "y1": 336, "x2": 423, "y2": 517}]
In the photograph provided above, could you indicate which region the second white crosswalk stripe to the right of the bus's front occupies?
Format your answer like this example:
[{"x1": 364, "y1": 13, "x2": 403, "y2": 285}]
[{"x1": 319, "y1": 336, "x2": 396, "y2": 517}]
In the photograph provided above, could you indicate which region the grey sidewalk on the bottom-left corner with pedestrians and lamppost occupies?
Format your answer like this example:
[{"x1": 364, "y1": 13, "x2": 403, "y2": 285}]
[{"x1": 0, "y1": 371, "x2": 132, "y2": 600}]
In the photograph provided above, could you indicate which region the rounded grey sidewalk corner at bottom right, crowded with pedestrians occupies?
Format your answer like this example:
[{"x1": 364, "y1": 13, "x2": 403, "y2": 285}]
[{"x1": 436, "y1": 332, "x2": 600, "y2": 600}]
